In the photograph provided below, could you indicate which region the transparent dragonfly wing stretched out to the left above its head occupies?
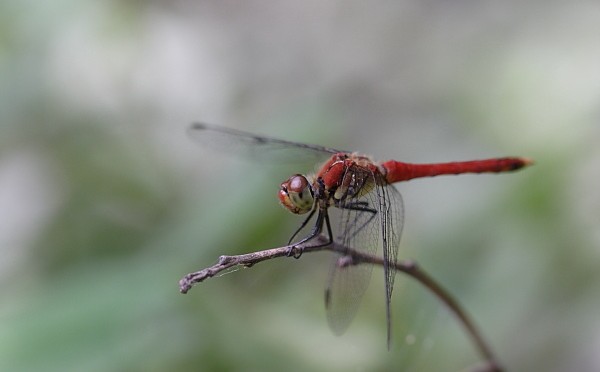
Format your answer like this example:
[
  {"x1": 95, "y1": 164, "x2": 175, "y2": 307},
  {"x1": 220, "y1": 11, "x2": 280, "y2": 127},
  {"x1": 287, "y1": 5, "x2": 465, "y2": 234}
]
[{"x1": 188, "y1": 123, "x2": 340, "y2": 163}]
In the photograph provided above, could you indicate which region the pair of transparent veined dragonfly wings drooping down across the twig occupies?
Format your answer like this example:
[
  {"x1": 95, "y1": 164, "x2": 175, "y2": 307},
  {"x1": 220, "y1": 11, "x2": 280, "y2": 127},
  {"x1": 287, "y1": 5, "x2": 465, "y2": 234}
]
[{"x1": 325, "y1": 168, "x2": 403, "y2": 335}]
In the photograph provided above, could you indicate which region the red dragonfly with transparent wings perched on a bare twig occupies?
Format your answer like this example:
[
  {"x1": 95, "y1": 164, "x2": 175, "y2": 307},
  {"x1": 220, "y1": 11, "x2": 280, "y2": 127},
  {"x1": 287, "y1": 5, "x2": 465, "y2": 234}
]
[{"x1": 190, "y1": 123, "x2": 531, "y2": 347}]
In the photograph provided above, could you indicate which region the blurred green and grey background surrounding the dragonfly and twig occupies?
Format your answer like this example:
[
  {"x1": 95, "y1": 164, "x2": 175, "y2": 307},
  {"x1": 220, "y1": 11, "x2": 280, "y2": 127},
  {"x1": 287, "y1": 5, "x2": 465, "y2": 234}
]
[{"x1": 0, "y1": 0, "x2": 600, "y2": 371}]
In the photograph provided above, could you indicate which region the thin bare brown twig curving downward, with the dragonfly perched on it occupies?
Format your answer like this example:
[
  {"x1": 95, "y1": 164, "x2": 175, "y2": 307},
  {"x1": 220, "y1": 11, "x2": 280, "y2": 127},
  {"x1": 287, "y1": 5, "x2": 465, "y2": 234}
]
[{"x1": 179, "y1": 236, "x2": 502, "y2": 372}]
